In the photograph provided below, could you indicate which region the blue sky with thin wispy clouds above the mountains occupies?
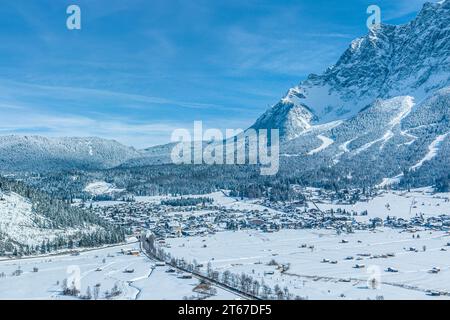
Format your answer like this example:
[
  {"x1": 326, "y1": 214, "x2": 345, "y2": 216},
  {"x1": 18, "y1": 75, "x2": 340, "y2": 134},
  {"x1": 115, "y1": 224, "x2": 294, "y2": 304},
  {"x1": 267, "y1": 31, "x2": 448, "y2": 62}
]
[{"x1": 0, "y1": 0, "x2": 440, "y2": 148}]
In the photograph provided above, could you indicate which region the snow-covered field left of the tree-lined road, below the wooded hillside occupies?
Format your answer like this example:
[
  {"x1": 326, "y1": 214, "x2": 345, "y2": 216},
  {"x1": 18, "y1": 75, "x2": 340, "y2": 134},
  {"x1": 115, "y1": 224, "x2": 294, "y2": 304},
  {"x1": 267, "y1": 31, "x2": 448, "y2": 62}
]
[{"x1": 0, "y1": 244, "x2": 238, "y2": 300}]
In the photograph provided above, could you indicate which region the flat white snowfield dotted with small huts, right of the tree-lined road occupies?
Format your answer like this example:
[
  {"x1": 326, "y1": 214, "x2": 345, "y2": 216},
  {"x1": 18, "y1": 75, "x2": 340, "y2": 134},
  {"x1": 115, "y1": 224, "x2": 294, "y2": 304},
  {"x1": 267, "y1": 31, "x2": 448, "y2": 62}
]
[{"x1": 163, "y1": 229, "x2": 450, "y2": 299}]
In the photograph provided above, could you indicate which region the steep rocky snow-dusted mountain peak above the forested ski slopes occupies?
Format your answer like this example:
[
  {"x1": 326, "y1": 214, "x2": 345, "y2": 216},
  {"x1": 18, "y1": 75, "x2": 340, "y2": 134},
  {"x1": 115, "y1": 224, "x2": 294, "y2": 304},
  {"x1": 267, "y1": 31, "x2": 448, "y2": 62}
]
[{"x1": 252, "y1": 1, "x2": 450, "y2": 140}]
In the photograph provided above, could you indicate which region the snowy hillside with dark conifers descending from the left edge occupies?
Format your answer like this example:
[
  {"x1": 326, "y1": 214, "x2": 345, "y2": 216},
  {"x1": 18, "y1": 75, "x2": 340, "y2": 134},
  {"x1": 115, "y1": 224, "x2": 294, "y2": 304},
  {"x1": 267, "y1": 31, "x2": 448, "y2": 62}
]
[{"x1": 0, "y1": 177, "x2": 124, "y2": 256}]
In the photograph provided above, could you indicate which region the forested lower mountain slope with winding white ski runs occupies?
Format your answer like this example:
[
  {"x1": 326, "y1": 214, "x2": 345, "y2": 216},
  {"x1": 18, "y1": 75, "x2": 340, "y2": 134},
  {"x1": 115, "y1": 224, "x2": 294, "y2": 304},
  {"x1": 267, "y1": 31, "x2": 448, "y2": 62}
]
[{"x1": 281, "y1": 88, "x2": 450, "y2": 186}]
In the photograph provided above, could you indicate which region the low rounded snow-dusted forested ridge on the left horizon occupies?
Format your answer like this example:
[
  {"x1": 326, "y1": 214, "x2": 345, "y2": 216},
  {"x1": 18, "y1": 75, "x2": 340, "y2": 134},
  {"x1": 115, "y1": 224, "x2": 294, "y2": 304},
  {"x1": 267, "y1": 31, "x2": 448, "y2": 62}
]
[{"x1": 0, "y1": 135, "x2": 140, "y2": 172}]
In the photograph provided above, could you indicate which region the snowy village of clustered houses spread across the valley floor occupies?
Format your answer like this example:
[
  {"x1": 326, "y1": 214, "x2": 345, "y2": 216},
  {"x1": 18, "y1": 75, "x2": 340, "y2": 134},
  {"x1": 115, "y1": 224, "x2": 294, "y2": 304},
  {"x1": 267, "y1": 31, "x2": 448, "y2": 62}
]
[{"x1": 80, "y1": 190, "x2": 450, "y2": 238}]
